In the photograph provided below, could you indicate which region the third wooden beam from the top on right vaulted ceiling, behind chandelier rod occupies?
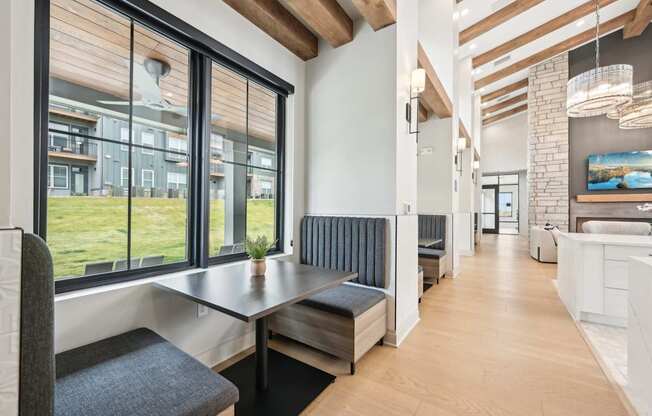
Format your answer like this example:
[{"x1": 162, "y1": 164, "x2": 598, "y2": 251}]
[{"x1": 475, "y1": 10, "x2": 635, "y2": 90}]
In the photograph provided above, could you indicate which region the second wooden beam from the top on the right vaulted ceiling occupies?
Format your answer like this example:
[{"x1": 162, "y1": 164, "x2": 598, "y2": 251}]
[{"x1": 473, "y1": 0, "x2": 616, "y2": 68}]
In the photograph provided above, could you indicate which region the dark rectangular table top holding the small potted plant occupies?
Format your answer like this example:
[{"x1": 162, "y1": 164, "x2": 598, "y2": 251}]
[{"x1": 155, "y1": 260, "x2": 358, "y2": 322}]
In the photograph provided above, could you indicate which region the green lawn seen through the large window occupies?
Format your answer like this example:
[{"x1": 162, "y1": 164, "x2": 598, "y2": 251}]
[{"x1": 47, "y1": 196, "x2": 275, "y2": 278}]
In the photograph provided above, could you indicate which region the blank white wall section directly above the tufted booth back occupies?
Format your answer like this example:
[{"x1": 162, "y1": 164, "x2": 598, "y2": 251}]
[{"x1": 306, "y1": 21, "x2": 397, "y2": 215}]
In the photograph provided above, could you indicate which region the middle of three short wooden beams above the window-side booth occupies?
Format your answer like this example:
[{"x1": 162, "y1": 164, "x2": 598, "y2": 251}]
[{"x1": 287, "y1": 0, "x2": 353, "y2": 48}]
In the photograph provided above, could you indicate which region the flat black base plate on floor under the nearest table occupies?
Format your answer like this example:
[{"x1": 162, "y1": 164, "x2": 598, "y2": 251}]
[{"x1": 220, "y1": 349, "x2": 335, "y2": 416}]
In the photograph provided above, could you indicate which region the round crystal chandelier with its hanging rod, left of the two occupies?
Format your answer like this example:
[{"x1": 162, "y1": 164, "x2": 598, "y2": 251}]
[{"x1": 566, "y1": 0, "x2": 634, "y2": 117}]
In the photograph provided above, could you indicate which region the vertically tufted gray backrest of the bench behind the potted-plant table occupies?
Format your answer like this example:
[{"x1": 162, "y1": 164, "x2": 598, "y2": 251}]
[{"x1": 301, "y1": 216, "x2": 387, "y2": 288}]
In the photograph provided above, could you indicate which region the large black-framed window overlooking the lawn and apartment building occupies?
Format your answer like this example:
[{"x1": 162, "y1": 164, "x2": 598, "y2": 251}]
[{"x1": 35, "y1": 0, "x2": 292, "y2": 292}]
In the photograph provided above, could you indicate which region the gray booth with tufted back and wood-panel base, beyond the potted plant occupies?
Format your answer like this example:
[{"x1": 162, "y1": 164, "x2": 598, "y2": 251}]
[{"x1": 269, "y1": 216, "x2": 387, "y2": 374}]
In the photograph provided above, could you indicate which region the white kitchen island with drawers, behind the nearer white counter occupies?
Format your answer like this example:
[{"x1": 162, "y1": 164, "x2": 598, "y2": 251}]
[{"x1": 557, "y1": 233, "x2": 652, "y2": 327}]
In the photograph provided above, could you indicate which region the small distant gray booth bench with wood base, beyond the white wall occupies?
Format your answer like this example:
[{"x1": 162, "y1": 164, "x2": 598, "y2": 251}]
[{"x1": 419, "y1": 215, "x2": 447, "y2": 284}]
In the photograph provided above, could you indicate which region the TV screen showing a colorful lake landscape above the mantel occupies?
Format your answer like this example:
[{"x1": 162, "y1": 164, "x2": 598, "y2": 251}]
[{"x1": 588, "y1": 150, "x2": 652, "y2": 191}]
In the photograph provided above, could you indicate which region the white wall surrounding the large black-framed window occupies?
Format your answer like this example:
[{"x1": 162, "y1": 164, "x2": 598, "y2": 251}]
[{"x1": 0, "y1": 0, "x2": 305, "y2": 364}]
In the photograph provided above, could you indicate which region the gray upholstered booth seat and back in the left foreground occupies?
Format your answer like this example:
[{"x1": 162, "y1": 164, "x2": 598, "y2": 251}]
[{"x1": 20, "y1": 234, "x2": 238, "y2": 416}]
